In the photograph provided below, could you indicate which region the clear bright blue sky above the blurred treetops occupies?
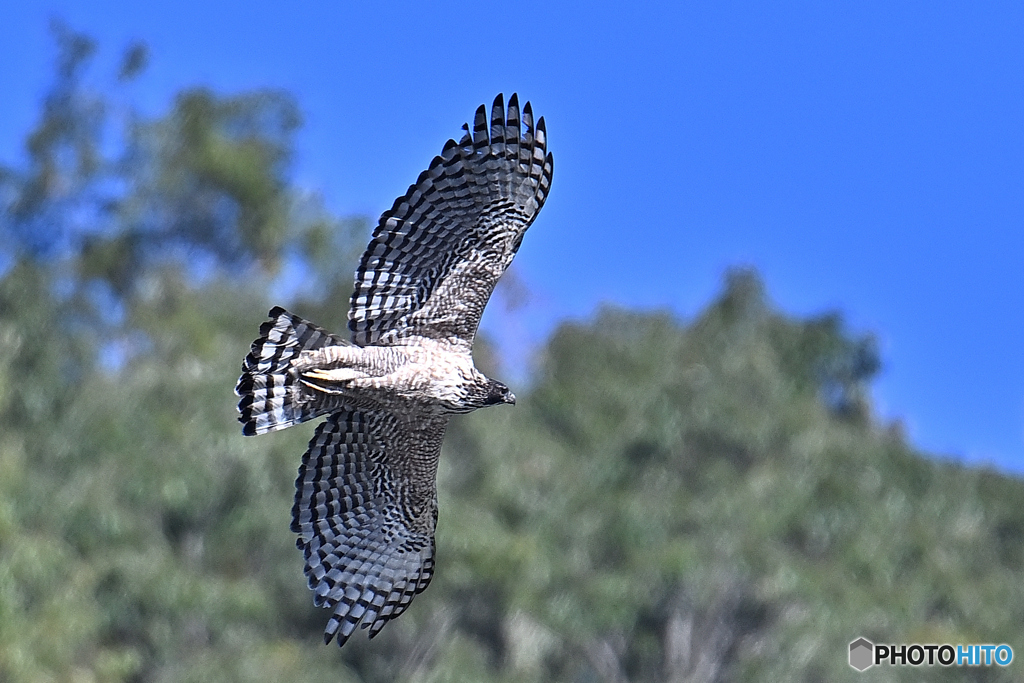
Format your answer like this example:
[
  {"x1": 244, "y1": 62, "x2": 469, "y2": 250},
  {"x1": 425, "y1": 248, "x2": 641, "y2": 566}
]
[{"x1": 0, "y1": 0, "x2": 1024, "y2": 472}]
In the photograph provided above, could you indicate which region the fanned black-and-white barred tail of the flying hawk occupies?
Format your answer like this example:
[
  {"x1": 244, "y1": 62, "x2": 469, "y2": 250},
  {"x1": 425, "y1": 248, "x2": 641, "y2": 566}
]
[{"x1": 234, "y1": 306, "x2": 351, "y2": 436}]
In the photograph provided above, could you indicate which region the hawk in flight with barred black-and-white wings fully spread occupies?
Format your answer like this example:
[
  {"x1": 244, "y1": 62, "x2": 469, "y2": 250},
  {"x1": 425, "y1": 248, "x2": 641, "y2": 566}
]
[{"x1": 236, "y1": 94, "x2": 553, "y2": 645}]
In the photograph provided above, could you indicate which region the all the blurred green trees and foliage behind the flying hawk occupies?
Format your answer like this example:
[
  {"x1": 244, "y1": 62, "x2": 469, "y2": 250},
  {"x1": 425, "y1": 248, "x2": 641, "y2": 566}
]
[{"x1": 0, "y1": 26, "x2": 1024, "y2": 683}]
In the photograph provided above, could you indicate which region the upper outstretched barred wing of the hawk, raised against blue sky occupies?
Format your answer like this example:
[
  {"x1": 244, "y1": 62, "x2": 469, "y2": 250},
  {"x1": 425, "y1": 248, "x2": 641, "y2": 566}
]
[{"x1": 348, "y1": 94, "x2": 553, "y2": 346}]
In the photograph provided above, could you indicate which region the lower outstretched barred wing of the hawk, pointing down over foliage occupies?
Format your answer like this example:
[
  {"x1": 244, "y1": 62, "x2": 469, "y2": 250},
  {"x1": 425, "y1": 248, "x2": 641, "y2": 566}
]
[{"x1": 292, "y1": 410, "x2": 447, "y2": 645}]
